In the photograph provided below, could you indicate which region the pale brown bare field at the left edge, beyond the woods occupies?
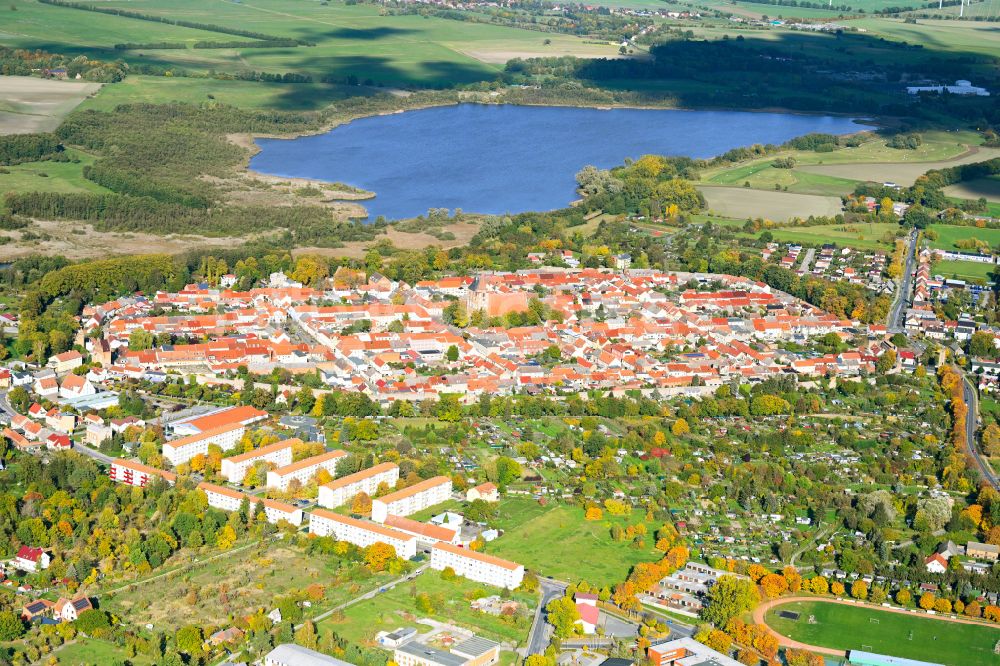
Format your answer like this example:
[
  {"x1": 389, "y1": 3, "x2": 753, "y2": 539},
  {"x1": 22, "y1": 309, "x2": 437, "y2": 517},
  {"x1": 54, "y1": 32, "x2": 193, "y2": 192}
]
[{"x1": 0, "y1": 76, "x2": 101, "y2": 134}]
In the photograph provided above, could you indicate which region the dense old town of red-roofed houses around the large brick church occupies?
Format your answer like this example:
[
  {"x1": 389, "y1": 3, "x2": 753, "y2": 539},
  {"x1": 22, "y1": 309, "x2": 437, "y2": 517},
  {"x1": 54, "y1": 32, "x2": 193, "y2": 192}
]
[{"x1": 56, "y1": 266, "x2": 916, "y2": 410}]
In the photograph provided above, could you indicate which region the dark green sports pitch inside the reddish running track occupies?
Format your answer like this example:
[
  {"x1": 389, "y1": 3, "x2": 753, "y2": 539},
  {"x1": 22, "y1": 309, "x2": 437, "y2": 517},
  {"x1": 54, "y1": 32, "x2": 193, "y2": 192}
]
[{"x1": 767, "y1": 601, "x2": 1000, "y2": 666}]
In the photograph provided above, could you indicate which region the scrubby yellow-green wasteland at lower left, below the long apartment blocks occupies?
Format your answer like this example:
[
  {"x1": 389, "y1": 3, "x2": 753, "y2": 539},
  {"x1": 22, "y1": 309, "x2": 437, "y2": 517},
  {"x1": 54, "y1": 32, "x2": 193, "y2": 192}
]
[{"x1": 96, "y1": 544, "x2": 389, "y2": 629}]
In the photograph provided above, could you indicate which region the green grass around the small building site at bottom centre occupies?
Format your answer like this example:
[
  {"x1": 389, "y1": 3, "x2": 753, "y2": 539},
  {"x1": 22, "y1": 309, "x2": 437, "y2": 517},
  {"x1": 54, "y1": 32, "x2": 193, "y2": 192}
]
[{"x1": 318, "y1": 570, "x2": 536, "y2": 646}]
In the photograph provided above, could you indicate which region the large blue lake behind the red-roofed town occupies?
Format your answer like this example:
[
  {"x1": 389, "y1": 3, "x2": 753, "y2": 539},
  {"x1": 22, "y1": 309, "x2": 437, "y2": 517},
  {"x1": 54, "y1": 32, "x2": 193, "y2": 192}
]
[{"x1": 250, "y1": 104, "x2": 863, "y2": 219}]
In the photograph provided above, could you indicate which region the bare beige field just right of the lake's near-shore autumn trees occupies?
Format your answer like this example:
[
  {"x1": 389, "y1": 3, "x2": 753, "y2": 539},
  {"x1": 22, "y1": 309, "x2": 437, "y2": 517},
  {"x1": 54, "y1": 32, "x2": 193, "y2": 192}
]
[{"x1": 699, "y1": 186, "x2": 842, "y2": 222}]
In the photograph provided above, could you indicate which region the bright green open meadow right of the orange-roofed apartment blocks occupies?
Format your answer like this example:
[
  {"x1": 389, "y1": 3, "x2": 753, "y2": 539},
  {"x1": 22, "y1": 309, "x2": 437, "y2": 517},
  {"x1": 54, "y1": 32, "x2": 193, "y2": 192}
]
[{"x1": 486, "y1": 498, "x2": 659, "y2": 586}]
